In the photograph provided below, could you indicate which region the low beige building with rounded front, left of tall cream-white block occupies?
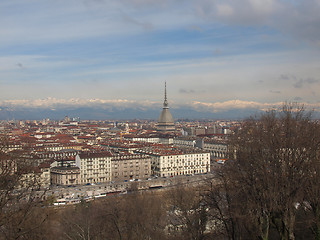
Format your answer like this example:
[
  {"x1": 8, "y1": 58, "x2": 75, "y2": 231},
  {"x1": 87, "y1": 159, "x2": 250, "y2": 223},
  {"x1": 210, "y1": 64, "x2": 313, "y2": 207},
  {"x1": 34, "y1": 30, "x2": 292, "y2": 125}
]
[{"x1": 51, "y1": 167, "x2": 80, "y2": 185}]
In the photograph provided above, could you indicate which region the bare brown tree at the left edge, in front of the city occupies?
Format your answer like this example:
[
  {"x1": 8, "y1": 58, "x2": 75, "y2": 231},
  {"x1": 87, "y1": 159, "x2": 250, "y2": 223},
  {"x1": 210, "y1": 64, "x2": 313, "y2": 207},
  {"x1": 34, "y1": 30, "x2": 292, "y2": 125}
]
[{"x1": 0, "y1": 137, "x2": 46, "y2": 239}]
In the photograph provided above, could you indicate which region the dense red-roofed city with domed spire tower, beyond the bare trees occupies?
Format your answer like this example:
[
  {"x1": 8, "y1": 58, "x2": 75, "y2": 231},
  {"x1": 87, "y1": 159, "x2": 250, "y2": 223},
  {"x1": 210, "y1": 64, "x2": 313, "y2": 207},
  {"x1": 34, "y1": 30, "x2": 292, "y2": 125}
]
[{"x1": 0, "y1": 85, "x2": 230, "y2": 191}]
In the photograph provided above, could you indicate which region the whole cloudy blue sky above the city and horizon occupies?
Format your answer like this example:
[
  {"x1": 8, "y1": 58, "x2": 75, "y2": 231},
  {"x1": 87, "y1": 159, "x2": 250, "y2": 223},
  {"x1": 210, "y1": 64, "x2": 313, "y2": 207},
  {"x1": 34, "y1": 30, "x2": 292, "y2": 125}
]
[{"x1": 0, "y1": 0, "x2": 320, "y2": 118}]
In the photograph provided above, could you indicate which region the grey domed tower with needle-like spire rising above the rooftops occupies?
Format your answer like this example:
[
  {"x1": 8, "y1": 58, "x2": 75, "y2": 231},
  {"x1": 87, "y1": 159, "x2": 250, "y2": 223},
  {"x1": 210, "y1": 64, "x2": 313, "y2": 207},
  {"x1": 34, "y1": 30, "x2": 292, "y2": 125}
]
[{"x1": 157, "y1": 83, "x2": 175, "y2": 133}]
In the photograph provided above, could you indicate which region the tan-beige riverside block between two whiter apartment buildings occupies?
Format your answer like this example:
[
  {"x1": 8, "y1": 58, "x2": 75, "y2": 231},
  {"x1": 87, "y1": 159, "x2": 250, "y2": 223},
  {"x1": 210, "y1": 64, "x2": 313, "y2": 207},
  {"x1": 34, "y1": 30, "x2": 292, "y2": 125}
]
[{"x1": 111, "y1": 154, "x2": 151, "y2": 181}]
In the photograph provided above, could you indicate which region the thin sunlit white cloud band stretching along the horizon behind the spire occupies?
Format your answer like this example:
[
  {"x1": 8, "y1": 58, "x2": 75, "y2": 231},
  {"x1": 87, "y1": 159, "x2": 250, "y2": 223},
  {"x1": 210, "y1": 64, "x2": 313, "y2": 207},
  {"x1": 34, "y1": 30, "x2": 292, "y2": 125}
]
[{"x1": 0, "y1": 98, "x2": 320, "y2": 113}]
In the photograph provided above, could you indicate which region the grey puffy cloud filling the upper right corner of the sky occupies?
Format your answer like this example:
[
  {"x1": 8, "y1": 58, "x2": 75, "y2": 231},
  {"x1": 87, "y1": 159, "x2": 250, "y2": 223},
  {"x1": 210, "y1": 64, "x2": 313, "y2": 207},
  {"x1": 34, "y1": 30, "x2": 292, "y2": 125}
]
[{"x1": 196, "y1": 0, "x2": 320, "y2": 46}]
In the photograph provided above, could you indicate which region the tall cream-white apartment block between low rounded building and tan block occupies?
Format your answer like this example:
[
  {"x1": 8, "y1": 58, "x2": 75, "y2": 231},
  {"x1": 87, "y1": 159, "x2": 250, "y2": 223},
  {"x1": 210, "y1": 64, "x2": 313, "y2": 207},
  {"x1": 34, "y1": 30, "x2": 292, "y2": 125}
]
[{"x1": 76, "y1": 152, "x2": 111, "y2": 184}]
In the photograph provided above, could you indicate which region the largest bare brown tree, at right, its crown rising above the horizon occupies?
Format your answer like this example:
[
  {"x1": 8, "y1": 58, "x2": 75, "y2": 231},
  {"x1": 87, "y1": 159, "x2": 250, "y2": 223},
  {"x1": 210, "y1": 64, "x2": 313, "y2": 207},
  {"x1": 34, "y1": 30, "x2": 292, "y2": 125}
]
[{"x1": 205, "y1": 104, "x2": 318, "y2": 239}]
